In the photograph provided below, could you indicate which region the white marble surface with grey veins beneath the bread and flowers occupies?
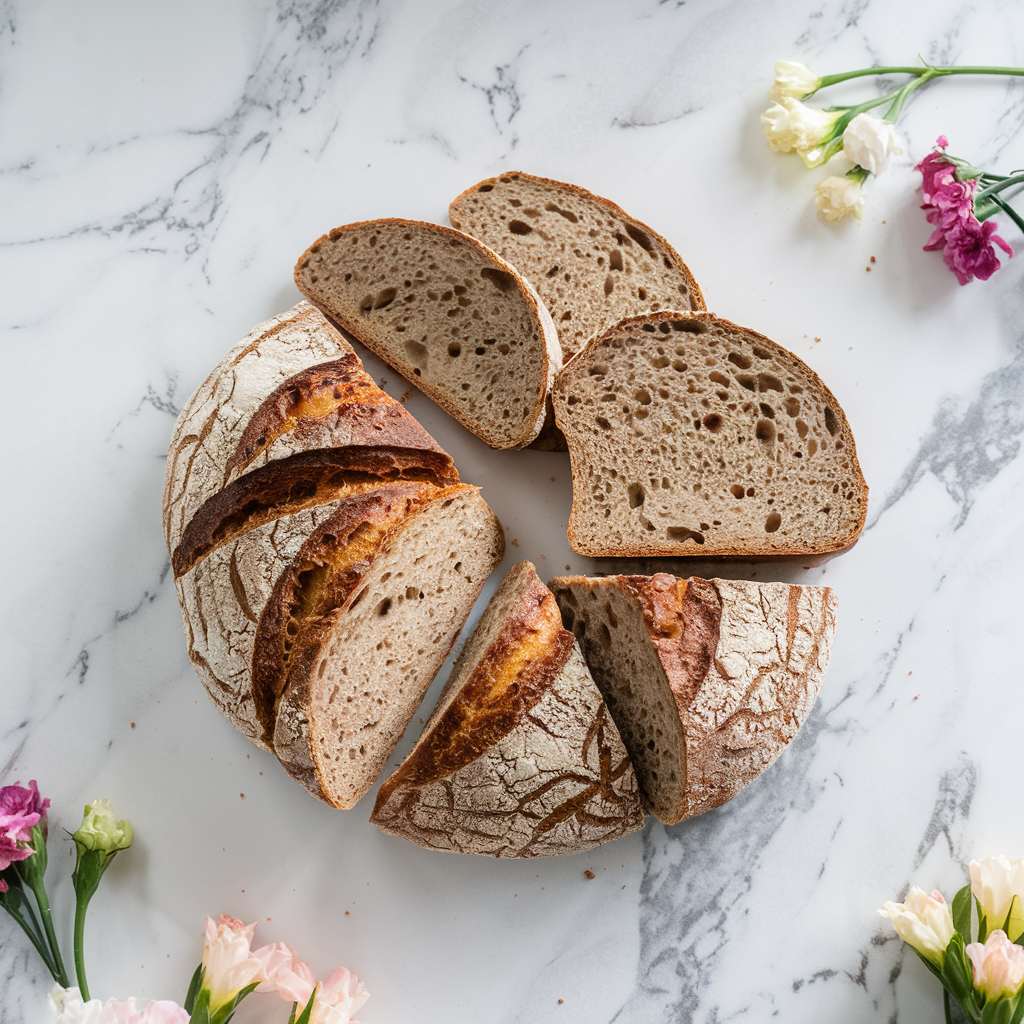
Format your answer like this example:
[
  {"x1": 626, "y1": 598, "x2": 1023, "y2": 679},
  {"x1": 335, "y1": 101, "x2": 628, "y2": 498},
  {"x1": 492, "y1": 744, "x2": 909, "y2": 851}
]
[{"x1": 0, "y1": 0, "x2": 1024, "y2": 1024}]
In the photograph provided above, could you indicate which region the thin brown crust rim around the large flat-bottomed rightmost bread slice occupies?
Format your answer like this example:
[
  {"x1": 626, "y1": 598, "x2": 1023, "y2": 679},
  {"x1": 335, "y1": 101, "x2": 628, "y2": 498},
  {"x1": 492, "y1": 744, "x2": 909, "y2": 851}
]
[{"x1": 552, "y1": 310, "x2": 868, "y2": 558}]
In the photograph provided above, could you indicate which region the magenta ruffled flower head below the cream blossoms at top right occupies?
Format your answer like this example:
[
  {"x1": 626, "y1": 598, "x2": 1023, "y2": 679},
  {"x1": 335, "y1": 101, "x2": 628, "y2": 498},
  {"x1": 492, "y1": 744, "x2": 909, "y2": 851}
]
[{"x1": 916, "y1": 135, "x2": 1014, "y2": 285}]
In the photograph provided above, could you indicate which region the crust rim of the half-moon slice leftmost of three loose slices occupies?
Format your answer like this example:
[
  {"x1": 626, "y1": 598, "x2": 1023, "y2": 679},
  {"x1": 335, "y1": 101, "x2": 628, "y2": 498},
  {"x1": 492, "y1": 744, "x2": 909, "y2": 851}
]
[{"x1": 295, "y1": 217, "x2": 562, "y2": 449}]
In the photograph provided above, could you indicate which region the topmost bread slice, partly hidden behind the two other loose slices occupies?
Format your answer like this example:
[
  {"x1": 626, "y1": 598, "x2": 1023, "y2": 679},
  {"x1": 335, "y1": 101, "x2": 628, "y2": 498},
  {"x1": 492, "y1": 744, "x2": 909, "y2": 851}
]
[{"x1": 449, "y1": 171, "x2": 705, "y2": 364}]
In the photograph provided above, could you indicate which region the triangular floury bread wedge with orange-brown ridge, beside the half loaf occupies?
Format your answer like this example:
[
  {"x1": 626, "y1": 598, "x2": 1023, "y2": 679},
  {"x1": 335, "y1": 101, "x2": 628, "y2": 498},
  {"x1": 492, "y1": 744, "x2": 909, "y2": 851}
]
[{"x1": 370, "y1": 562, "x2": 644, "y2": 857}]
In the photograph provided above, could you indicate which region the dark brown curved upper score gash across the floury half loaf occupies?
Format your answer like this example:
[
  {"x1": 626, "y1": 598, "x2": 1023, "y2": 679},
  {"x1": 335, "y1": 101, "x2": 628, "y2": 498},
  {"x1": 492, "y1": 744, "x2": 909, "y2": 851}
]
[{"x1": 171, "y1": 444, "x2": 459, "y2": 578}]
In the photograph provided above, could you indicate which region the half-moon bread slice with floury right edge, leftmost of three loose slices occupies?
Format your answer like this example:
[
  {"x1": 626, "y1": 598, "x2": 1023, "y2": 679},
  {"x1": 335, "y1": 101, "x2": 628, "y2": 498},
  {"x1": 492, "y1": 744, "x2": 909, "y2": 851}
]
[{"x1": 295, "y1": 219, "x2": 561, "y2": 449}]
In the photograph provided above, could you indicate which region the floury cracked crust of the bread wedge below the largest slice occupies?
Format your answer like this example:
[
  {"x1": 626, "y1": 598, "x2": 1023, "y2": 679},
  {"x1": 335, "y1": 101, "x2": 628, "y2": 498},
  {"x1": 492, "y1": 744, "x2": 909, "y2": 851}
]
[{"x1": 550, "y1": 573, "x2": 838, "y2": 824}]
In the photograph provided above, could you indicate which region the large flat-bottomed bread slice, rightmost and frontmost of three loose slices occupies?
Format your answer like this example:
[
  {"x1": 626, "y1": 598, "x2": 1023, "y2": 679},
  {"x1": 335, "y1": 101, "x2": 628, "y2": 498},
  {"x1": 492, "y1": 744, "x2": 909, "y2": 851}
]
[{"x1": 552, "y1": 312, "x2": 867, "y2": 557}]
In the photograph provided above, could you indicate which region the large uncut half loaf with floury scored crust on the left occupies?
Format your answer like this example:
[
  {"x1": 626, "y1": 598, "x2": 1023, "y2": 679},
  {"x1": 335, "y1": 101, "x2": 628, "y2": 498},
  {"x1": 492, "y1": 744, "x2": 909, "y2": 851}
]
[{"x1": 164, "y1": 302, "x2": 504, "y2": 807}]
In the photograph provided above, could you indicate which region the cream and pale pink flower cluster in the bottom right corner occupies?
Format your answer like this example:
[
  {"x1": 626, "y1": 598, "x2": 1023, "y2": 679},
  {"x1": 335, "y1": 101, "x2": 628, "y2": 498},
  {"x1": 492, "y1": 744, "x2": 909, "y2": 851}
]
[{"x1": 879, "y1": 856, "x2": 1024, "y2": 1024}]
